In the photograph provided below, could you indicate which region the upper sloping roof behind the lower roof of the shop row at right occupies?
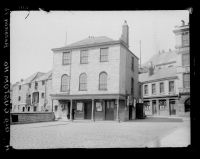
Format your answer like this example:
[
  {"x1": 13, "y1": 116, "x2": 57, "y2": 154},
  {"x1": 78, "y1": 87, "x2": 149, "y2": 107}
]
[{"x1": 143, "y1": 50, "x2": 177, "y2": 66}]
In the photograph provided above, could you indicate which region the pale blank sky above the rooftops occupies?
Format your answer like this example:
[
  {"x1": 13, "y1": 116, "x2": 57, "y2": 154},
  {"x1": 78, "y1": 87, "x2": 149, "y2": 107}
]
[{"x1": 10, "y1": 10, "x2": 189, "y2": 84}]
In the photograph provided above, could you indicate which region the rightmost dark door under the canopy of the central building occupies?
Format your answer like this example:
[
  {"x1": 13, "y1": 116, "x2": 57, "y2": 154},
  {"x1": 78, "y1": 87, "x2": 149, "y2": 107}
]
[{"x1": 105, "y1": 101, "x2": 114, "y2": 120}]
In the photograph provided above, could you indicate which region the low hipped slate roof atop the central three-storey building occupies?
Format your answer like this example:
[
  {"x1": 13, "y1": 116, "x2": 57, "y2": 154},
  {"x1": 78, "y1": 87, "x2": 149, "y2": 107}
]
[{"x1": 52, "y1": 36, "x2": 115, "y2": 50}]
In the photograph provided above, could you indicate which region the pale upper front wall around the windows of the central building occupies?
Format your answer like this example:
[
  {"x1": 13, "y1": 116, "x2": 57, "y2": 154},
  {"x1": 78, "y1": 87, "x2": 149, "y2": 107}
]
[{"x1": 52, "y1": 45, "x2": 120, "y2": 95}]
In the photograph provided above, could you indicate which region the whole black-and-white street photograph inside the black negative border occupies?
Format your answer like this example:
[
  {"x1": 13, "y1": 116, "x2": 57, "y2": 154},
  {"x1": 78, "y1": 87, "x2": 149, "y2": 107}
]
[{"x1": 10, "y1": 9, "x2": 191, "y2": 150}]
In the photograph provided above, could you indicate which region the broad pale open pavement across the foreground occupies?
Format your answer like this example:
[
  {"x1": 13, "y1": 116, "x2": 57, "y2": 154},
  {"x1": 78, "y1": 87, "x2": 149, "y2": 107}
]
[{"x1": 10, "y1": 117, "x2": 190, "y2": 149}]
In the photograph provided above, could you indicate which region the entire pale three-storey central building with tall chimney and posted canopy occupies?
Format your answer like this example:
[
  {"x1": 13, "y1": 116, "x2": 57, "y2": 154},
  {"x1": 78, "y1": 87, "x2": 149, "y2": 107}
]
[{"x1": 50, "y1": 21, "x2": 138, "y2": 121}]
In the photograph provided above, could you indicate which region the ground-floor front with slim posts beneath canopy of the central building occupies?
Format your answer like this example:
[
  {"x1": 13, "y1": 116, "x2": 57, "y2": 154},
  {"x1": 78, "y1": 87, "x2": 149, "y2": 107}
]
[{"x1": 51, "y1": 94, "x2": 130, "y2": 121}]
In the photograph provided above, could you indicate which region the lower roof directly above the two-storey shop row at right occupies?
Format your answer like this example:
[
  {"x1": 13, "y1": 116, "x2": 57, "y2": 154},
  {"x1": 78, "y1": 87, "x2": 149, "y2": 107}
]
[{"x1": 139, "y1": 67, "x2": 177, "y2": 82}]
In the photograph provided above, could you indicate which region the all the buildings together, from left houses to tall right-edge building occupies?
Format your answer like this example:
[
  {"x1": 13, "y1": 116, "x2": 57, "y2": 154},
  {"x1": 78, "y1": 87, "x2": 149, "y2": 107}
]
[{"x1": 11, "y1": 21, "x2": 190, "y2": 120}]
